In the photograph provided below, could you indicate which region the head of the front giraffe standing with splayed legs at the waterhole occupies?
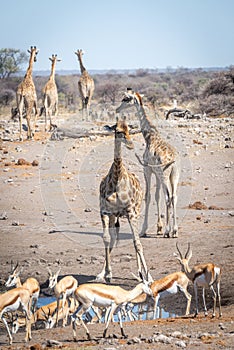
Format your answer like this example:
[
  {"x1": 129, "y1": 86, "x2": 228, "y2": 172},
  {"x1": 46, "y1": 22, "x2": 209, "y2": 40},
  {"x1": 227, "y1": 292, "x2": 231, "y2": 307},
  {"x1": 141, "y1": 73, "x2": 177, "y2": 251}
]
[{"x1": 105, "y1": 116, "x2": 134, "y2": 149}]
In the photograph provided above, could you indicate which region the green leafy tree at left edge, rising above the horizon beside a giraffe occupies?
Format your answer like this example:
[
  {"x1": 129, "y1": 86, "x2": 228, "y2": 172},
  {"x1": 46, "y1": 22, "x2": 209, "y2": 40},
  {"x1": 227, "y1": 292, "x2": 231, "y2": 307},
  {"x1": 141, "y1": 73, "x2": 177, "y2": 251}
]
[{"x1": 0, "y1": 48, "x2": 28, "y2": 79}]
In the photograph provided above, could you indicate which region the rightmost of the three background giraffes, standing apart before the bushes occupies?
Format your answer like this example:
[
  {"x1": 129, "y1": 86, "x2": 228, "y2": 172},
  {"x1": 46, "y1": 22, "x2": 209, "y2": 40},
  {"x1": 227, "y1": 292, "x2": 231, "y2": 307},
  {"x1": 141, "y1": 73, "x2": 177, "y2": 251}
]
[{"x1": 75, "y1": 50, "x2": 94, "y2": 118}]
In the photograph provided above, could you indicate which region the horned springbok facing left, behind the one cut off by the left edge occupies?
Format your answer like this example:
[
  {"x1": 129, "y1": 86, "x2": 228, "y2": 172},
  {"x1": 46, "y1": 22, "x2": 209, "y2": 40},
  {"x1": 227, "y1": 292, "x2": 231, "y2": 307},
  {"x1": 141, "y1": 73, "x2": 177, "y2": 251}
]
[{"x1": 5, "y1": 263, "x2": 40, "y2": 313}]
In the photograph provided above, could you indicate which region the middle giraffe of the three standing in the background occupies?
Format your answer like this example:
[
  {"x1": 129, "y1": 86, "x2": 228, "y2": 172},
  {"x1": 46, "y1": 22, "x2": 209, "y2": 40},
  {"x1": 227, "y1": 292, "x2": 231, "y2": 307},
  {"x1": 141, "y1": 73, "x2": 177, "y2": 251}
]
[{"x1": 41, "y1": 55, "x2": 61, "y2": 131}]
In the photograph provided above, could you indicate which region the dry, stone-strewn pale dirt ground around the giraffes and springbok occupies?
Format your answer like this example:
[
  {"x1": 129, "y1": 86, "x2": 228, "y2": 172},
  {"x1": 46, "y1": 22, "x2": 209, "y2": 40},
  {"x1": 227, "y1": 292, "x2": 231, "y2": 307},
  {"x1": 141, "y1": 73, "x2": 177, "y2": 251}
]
[{"x1": 0, "y1": 115, "x2": 234, "y2": 349}]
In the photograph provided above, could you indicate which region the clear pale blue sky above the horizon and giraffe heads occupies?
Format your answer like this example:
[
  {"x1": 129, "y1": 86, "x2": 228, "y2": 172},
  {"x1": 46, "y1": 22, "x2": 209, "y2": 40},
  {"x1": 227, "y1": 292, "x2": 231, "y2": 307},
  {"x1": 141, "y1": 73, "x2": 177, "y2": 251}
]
[{"x1": 0, "y1": 0, "x2": 234, "y2": 70}]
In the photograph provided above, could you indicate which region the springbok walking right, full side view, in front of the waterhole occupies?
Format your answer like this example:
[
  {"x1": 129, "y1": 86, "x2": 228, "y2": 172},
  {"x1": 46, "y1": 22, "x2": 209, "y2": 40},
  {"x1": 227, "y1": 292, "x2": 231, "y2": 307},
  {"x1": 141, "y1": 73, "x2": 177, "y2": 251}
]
[{"x1": 72, "y1": 271, "x2": 152, "y2": 340}]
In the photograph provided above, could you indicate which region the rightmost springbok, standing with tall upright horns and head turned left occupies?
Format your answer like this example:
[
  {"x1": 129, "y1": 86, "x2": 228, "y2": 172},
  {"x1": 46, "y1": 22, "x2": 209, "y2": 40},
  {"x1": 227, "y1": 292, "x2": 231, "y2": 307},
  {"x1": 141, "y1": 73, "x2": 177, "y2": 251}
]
[{"x1": 175, "y1": 244, "x2": 222, "y2": 317}]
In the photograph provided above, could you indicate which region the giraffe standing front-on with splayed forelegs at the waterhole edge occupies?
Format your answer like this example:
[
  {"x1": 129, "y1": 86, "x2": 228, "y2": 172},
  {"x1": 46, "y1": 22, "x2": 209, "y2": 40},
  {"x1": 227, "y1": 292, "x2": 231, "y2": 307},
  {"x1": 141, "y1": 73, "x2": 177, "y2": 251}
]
[{"x1": 97, "y1": 118, "x2": 151, "y2": 281}]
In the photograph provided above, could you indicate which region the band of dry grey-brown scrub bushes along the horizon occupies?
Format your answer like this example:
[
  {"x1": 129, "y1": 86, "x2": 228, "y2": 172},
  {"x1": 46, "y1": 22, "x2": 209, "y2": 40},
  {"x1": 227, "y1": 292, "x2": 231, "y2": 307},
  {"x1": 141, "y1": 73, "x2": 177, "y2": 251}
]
[{"x1": 0, "y1": 66, "x2": 234, "y2": 117}]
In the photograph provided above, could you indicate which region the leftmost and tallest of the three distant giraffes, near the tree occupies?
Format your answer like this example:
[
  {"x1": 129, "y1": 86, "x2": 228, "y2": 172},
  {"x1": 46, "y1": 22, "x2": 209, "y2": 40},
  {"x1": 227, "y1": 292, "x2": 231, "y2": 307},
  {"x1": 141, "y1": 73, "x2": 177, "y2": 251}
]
[{"x1": 16, "y1": 46, "x2": 39, "y2": 141}]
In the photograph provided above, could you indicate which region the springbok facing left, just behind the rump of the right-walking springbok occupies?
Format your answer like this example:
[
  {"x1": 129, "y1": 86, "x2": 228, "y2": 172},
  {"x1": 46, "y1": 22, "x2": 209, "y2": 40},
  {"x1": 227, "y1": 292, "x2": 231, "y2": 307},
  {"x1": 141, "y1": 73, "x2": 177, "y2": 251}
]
[{"x1": 47, "y1": 268, "x2": 78, "y2": 327}]
